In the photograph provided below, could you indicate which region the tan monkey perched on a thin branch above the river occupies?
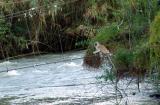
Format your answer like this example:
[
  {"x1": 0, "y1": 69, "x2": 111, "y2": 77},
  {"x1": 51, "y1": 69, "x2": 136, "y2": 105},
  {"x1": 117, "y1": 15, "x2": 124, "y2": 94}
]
[{"x1": 93, "y1": 42, "x2": 111, "y2": 55}]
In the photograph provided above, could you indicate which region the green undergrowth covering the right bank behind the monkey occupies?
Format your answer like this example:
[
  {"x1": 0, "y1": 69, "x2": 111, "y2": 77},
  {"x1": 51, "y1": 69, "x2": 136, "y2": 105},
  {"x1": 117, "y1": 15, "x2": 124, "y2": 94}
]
[{"x1": 84, "y1": 0, "x2": 160, "y2": 89}]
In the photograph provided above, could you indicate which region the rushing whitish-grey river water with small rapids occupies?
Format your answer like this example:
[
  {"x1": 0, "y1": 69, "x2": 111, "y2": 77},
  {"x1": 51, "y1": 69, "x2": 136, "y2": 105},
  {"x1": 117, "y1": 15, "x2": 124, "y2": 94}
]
[{"x1": 0, "y1": 51, "x2": 159, "y2": 105}]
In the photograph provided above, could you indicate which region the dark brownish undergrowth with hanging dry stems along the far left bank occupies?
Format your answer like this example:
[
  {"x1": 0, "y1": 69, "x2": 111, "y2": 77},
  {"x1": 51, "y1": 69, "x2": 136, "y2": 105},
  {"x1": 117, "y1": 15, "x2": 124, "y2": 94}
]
[{"x1": 0, "y1": 0, "x2": 95, "y2": 59}]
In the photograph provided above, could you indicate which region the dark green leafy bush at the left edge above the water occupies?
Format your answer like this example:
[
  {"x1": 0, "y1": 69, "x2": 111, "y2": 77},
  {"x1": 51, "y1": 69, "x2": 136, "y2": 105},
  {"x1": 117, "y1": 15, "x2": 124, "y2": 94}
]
[{"x1": 0, "y1": 15, "x2": 27, "y2": 59}]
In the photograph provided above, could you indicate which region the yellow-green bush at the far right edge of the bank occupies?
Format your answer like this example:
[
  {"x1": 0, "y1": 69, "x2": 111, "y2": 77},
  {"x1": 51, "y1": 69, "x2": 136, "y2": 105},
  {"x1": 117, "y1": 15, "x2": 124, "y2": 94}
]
[{"x1": 149, "y1": 12, "x2": 160, "y2": 92}]
